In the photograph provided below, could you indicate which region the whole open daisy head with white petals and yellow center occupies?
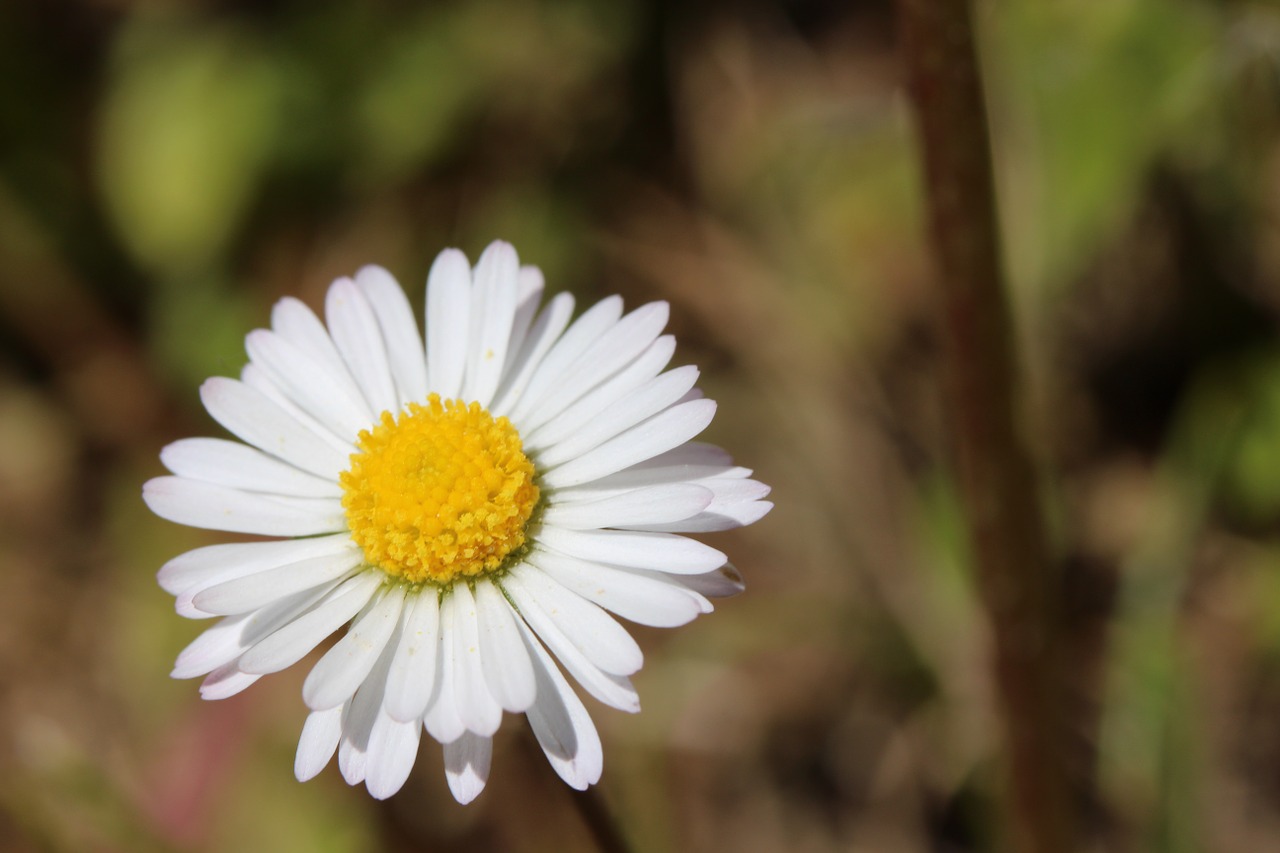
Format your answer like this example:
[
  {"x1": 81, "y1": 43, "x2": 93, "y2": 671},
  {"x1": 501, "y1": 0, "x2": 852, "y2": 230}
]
[{"x1": 143, "y1": 242, "x2": 772, "y2": 803}]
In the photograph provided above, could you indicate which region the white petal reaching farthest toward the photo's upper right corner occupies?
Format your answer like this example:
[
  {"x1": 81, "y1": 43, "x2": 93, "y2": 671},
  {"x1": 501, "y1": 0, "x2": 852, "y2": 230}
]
[{"x1": 521, "y1": 302, "x2": 684, "y2": 429}]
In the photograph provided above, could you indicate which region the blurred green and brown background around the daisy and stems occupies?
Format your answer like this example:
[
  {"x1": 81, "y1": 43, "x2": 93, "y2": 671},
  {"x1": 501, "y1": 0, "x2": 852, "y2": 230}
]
[{"x1": 0, "y1": 0, "x2": 1280, "y2": 853}]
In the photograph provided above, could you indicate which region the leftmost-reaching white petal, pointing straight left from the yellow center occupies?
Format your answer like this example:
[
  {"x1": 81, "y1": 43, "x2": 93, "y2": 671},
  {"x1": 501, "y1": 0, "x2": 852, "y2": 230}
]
[{"x1": 142, "y1": 476, "x2": 347, "y2": 537}]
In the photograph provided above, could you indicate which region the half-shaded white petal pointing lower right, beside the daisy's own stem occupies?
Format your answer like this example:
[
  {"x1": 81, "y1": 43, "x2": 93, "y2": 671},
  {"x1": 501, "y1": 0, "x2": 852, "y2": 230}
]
[{"x1": 520, "y1": 614, "x2": 604, "y2": 790}]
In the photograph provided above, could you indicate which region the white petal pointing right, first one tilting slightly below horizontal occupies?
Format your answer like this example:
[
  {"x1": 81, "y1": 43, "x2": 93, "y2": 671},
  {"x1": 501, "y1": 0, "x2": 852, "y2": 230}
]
[{"x1": 538, "y1": 526, "x2": 727, "y2": 575}]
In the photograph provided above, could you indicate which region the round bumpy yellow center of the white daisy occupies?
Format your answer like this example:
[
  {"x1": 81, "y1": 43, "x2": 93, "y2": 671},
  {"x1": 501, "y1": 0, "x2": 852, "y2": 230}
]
[{"x1": 339, "y1": 394, "x2": 538, "y2": 584}]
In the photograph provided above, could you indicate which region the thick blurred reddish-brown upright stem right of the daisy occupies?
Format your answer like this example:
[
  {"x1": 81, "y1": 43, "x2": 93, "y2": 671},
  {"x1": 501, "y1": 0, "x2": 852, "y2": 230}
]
[{"x1": 899, "y1": 0, "x2": 1074, "y2": 853}]
